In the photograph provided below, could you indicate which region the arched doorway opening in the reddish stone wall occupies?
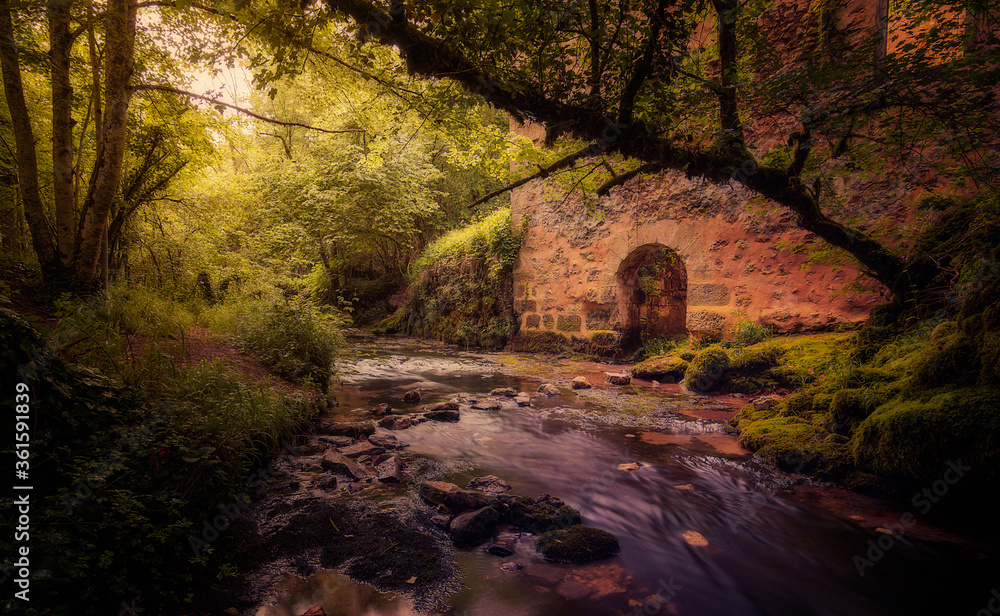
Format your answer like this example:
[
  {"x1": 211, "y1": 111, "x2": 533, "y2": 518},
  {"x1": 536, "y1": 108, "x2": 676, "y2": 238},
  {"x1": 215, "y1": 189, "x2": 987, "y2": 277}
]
[{"x1": 618, "y1": 244, "x2": 687, "y2": 345}]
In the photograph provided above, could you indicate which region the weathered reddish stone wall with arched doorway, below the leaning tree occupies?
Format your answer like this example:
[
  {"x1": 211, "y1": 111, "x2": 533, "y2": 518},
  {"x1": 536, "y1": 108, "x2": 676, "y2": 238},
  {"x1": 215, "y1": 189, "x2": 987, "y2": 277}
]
[{"x1": 511, "y1": 127, "x2": 888, "y2": 346}]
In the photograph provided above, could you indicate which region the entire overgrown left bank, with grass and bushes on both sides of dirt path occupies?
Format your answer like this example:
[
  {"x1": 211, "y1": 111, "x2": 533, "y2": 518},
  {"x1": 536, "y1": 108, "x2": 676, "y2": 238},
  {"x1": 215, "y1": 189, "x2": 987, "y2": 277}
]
[{"x1": 0, "y1": 289, "x2": 339, "y2": 614}]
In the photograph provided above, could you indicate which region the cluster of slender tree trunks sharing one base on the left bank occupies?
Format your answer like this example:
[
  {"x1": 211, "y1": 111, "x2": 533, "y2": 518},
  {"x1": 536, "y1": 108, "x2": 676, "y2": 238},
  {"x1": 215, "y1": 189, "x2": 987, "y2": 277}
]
[{"x1": 0, "y1": 0, "x2": 136, "y2": 287}]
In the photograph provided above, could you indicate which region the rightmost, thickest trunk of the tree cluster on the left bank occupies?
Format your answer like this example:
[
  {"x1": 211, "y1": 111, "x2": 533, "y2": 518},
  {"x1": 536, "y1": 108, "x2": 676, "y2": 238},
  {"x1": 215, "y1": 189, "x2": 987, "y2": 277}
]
[{"x1": 75, "y1": 0, "x2": 136, "y2": 286}]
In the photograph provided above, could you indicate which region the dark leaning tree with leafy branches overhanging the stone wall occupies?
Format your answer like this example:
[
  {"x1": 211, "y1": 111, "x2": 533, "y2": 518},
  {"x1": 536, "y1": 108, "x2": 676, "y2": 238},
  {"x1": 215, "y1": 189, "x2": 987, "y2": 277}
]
[{"x1": 318, "y1": 0, "x2": 998, "y2": 301}]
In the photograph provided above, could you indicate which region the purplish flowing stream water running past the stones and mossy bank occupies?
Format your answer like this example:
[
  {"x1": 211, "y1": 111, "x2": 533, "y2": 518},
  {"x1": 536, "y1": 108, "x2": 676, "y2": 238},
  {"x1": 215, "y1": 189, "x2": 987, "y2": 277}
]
[{"x1": 258, "y1": 340, "x2": 1000, "y2": 616}]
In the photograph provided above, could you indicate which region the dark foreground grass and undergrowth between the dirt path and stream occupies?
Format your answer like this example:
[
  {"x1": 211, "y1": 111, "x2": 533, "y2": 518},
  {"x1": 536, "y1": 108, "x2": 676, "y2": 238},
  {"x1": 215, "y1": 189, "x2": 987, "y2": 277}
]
[{"x1": 0, "y1": 310, "x2": 307, "y2": 614}]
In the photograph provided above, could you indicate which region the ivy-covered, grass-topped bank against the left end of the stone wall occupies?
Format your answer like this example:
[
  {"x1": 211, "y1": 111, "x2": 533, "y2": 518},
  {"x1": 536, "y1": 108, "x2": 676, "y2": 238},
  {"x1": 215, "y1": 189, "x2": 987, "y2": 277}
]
[{"x1": 378, "y1": 209, "x2": 521, "y2": 349}]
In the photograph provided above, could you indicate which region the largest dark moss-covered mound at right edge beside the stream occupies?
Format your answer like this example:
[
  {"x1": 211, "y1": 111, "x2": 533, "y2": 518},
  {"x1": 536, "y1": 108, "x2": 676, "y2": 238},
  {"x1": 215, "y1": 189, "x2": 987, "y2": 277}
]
[{"x1": 851, "y1": 387, "x2": 1000, "y2": 482}]
